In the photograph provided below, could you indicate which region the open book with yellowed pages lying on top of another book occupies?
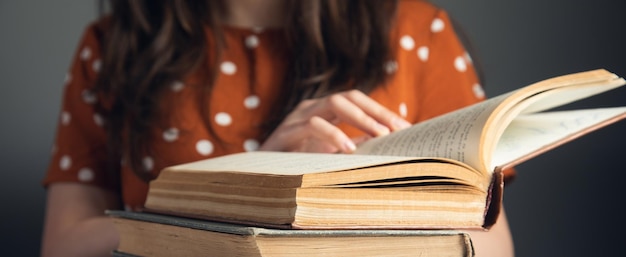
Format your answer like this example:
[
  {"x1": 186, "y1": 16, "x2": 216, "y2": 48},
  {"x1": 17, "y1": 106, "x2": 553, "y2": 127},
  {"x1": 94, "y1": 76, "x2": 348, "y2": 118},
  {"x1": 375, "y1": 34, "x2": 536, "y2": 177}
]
[{"x1": 146, "y1": 70, "x2": 626, "y2": 229}]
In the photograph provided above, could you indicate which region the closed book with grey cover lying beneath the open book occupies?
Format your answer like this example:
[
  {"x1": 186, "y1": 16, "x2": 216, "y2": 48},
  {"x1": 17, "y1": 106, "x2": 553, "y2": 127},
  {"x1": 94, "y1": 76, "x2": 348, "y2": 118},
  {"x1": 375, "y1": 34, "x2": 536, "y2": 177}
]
[{"x1": 107, "y1": 211, "x2": 474, "y2": 257}]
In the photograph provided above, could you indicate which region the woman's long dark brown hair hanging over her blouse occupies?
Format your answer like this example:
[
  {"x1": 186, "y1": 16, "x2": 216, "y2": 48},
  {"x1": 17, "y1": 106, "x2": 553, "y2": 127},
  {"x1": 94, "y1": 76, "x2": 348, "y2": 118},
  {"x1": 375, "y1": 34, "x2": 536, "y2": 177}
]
[{"x1": 95, "y1": 0, "x2": 397, "y2": 180}]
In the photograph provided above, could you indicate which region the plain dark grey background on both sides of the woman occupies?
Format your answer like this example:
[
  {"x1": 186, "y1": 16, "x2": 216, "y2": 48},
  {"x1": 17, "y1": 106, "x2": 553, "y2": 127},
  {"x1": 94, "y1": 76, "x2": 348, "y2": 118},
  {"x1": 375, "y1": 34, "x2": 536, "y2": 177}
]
[{"x1": 0, "y1": 0, "x2": 626, "y2": 256}]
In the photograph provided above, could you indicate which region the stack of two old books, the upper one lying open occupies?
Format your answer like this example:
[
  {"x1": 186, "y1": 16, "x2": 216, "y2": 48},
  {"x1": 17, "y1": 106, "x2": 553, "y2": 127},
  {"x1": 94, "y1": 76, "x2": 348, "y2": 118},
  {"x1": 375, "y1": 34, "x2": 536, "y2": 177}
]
[{"x1": 108, "y1": 70, "x2": 626, "y2": 256}]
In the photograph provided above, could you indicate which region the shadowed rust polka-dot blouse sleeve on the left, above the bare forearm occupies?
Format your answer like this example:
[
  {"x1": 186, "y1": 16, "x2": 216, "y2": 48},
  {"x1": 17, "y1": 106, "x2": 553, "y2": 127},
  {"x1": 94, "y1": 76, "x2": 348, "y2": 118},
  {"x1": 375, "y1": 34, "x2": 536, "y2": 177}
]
[{"x1": 42, "y1": 24, "x2": 118, "y2": 190}]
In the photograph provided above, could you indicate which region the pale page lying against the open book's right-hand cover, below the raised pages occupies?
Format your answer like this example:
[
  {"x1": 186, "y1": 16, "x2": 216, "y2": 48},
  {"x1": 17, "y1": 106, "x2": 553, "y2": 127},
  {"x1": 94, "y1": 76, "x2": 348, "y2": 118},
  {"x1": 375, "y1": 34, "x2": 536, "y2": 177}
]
[{"x1": 491, "y1": 107, "x2": 626, "y2": 169}]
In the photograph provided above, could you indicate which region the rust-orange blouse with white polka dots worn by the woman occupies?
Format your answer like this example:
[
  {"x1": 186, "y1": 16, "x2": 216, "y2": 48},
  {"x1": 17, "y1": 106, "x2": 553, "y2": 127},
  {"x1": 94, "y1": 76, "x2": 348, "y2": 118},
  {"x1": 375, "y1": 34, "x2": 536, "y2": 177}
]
[{"x1": 43, "y1": 1, "x2": 498, "y2": 209}]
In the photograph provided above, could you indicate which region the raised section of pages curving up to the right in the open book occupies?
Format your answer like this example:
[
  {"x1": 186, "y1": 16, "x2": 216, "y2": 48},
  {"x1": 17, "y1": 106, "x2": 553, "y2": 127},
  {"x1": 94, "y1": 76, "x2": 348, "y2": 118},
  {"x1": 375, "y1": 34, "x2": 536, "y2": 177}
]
[{"x1": 356, "y1": 70, "x2": 625, "y2": 172}]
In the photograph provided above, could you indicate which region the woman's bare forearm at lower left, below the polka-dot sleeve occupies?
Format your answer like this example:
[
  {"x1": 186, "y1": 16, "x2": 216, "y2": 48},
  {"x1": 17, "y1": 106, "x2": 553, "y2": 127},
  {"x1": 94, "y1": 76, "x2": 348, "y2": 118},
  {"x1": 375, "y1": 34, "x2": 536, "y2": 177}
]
[{"x1": 41, "y1": 183, "x2": 119, "y2": 257}]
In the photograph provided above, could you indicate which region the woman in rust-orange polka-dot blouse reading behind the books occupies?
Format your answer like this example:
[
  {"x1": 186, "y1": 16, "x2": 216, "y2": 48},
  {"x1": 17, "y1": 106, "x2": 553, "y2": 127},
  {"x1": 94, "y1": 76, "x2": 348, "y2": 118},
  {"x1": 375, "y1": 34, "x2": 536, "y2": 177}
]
[{"x1": 42, "y1": 0, "x2": 512, "y2": 256}]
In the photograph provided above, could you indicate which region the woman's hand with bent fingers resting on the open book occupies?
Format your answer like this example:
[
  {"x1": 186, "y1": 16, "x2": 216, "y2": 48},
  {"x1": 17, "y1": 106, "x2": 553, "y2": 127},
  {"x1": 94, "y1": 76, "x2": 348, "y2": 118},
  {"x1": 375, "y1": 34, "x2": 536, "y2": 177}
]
[{"x1": 260, "y1": 90, "x2": 411, "y2": 153}]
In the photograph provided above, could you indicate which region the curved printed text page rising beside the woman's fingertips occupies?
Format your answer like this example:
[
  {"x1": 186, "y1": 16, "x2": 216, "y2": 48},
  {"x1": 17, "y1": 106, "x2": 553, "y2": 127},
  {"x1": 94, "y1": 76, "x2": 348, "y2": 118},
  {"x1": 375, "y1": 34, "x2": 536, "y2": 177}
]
[{"x1": 356, "y1": 93, "x2": 510, "y2": 170}]
